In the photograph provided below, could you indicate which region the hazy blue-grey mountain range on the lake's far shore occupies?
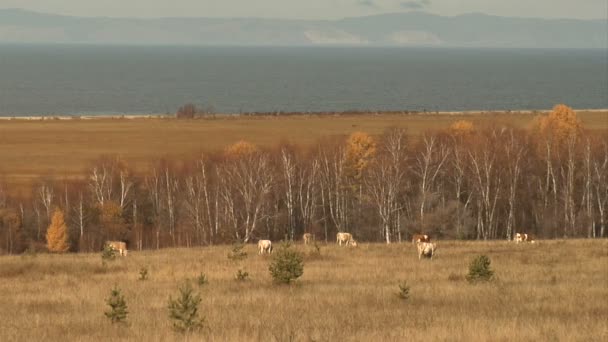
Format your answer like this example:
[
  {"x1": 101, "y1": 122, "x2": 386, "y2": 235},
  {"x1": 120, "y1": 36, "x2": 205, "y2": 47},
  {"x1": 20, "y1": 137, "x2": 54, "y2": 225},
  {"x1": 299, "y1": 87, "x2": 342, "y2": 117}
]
[{"x1": 0, "y1": 9, "x2": 608, "y2": 48}]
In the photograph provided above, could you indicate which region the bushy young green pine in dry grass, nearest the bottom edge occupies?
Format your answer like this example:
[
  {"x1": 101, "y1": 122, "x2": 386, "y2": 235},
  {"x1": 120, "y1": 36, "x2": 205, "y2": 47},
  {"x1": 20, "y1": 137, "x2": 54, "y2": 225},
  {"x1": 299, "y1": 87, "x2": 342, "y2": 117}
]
[{"x1": 168, "y1": 283, "x2": 204, "y2": 333}]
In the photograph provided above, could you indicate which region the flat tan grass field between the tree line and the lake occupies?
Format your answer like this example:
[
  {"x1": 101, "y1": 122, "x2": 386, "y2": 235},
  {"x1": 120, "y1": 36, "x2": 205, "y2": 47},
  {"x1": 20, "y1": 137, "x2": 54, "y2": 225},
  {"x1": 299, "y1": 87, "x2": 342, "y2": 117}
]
[{"x1": 0, "y1": 111, "x2": 608, "y2": 182}]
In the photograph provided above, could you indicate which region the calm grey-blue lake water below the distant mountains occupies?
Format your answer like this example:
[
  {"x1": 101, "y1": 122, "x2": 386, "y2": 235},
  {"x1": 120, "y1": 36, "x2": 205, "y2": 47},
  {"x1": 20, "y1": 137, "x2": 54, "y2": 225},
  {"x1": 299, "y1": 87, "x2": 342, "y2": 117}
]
[{"x1": 0, "y1": 45, "x2": 608, "y2": 116}]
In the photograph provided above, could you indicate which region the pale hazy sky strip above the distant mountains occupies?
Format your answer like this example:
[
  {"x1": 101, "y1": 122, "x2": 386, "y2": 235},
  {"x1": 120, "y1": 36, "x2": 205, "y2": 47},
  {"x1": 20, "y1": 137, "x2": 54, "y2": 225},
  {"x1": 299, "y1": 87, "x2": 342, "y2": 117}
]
[{"x1": 0, "y1": 0, "x2": 608, "y2": 19}]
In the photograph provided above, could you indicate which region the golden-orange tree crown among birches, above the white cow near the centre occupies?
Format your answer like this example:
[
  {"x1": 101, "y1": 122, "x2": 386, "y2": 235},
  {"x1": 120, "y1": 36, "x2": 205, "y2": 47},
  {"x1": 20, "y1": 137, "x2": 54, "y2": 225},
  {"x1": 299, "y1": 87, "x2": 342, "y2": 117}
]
[{"x1": 346, "y1": 132, "x2": 376, "y2": 180}]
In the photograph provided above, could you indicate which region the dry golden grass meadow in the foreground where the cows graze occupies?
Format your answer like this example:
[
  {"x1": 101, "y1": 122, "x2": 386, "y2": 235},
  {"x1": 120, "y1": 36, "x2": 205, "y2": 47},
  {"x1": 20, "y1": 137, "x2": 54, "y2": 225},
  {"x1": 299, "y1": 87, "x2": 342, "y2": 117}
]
[{"x1": 0, "y1": 240, "x2": 608, "y2": 341}]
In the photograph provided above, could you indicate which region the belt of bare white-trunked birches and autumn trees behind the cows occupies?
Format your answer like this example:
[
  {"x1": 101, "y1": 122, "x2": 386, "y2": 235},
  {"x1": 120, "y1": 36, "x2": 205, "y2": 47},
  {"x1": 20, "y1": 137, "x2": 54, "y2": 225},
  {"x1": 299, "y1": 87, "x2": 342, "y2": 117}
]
[{"x1": 0, "y1": 105, "x2": 608, "y2": 253}]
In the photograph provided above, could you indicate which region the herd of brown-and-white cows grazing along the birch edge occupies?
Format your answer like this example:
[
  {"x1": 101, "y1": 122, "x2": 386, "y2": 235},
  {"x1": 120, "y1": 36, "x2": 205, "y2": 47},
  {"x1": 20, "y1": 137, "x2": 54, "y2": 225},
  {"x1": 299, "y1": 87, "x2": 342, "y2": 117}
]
[{"x1": 106, "y1": 232, "x2": 536, "y2": 260}]
